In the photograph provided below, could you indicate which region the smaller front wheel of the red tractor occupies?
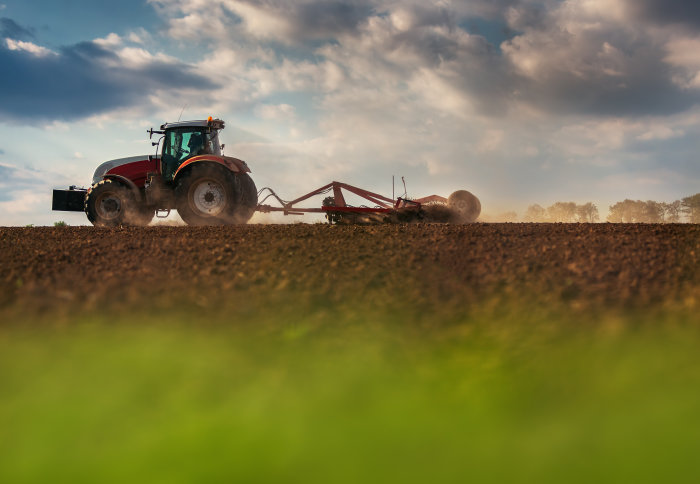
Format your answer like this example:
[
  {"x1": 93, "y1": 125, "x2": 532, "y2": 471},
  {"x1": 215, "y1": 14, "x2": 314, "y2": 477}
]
[{"x1": 85, "y1": 180, "x2": 153, "y2": 227}]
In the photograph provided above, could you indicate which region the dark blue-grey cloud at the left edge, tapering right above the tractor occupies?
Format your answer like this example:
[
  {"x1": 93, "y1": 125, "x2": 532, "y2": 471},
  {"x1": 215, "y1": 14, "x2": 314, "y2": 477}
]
[{"x1": 0, "y1": 36, "x2": 215, "y2": 120}]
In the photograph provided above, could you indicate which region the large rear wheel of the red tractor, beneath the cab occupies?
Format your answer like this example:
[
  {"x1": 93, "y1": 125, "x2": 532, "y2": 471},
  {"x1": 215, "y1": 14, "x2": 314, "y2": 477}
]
[{"x1": 175, "y1": 163, "x2": 240, "y2": 225}]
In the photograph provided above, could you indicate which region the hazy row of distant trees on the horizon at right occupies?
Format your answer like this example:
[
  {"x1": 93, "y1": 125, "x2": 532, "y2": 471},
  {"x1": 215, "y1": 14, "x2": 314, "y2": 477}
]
[{"x1": 523, "y1": 193, "x2": 700, "y2": 223}]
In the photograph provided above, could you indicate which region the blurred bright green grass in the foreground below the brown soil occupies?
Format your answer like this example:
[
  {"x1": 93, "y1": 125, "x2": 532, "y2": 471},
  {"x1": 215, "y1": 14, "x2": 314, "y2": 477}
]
[{"x1": 0, "y1": 307, "x2": 700, "y2": 483}]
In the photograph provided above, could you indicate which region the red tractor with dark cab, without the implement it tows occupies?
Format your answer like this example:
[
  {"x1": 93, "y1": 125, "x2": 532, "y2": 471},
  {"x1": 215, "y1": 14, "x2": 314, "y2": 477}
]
[{"x1": 53, "y1": 117, "x2": 258, "y2": 227}]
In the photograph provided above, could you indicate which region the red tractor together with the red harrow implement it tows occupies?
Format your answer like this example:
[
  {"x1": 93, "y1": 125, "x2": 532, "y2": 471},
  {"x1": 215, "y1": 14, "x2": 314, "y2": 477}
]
[{"x1": 52, "y1": 117, "x2": 481, "y2": 227}]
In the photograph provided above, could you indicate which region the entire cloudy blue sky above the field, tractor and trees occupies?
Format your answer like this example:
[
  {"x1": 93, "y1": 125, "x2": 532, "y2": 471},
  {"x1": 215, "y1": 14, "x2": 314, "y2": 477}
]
[{"x1": 0, "y1": 0, "x2": 700, "y2": 225}]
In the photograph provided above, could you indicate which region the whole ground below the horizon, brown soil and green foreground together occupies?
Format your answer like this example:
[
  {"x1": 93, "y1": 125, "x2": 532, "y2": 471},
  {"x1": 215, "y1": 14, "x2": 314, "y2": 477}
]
[{"x1": 0, "y1": 224, "x2": 700, "y2": 484}]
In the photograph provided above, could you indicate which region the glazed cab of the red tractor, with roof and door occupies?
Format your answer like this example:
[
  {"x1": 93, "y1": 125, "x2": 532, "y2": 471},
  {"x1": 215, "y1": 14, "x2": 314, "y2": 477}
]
[{"x1": 158, "y1": 118, "x2": 224, "y2": 182}]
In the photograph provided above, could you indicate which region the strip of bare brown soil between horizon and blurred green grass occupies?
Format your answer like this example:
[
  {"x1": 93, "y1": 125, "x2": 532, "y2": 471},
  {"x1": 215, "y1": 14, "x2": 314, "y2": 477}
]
[{"x1": 0, "y1": 224, "x2": 700, "y2": 320}]
